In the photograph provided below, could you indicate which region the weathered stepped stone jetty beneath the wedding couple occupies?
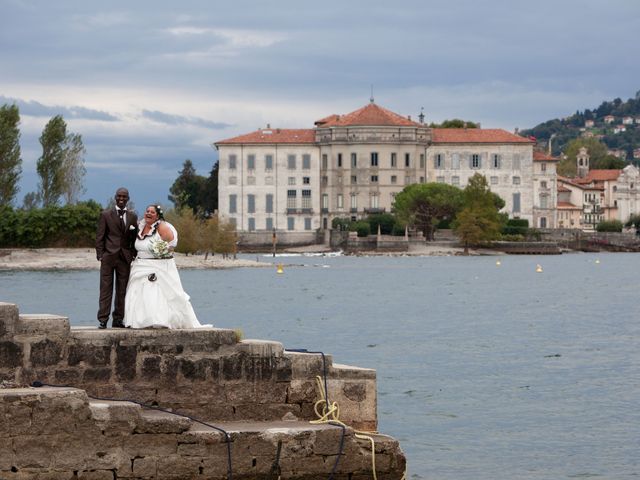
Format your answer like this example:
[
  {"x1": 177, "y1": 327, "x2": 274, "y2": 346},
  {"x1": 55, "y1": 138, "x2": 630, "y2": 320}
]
[{"x1": 0, "y1": 303, "x2": 405, "y2": 480}]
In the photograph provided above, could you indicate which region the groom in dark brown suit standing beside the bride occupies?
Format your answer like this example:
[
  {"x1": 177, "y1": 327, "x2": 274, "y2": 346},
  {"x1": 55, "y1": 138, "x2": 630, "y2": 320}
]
[{"x1": 96, "y1": 188, "x2": 138, "y2": 328}]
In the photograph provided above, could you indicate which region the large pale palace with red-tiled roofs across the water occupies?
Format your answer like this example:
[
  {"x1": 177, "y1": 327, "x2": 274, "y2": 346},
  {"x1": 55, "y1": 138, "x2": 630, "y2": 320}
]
[{"x1": 215, "y1": 101, "x2": 556, "y2": 234}]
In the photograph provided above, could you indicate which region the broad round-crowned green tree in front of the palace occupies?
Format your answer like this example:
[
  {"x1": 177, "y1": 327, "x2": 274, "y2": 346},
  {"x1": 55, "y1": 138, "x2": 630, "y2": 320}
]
[{"x1": 393, "y1": 183, "x2": 462, "y2": 240}]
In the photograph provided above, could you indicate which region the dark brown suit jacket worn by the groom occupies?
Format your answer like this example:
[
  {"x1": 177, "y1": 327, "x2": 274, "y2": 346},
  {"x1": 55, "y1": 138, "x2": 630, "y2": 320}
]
[{"x1": 96, "y1": 207, "x2": 138, "y2": 263}]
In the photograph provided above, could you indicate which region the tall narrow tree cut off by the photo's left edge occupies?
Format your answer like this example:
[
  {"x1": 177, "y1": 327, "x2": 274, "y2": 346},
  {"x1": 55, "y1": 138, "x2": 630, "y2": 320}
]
[{"x1": 0, "y1": 104, "x2": 22, "y2": 206}]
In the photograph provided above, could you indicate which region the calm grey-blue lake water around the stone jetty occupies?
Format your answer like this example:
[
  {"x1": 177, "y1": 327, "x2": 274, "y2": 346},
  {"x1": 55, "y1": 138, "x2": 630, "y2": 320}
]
[{"x1": 0, "y1": 254, "x2": 640, "y2": 480}]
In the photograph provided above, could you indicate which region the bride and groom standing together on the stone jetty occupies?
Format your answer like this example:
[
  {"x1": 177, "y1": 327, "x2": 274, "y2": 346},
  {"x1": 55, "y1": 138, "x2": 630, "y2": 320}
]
[{"x1": 96, "y1": 188, "x2": 210, "y2": 328}]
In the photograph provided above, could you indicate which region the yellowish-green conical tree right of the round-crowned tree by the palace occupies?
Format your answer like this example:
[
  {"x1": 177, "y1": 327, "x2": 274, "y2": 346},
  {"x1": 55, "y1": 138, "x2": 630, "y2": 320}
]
[{"x1": 453, "y1": 173, "x2": 504, "y2": 254}]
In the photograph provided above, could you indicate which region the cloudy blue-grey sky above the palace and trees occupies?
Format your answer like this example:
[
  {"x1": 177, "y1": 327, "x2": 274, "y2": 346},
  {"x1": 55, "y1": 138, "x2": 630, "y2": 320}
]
[{"x1": 0, "y1": 0, "x2": 640, "y2": 210}]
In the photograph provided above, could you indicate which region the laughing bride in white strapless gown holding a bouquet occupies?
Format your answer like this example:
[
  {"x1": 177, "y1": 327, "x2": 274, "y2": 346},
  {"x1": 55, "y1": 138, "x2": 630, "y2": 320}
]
[{"x1": 124, "y1": 205, "x2": 210, "y2": 328}]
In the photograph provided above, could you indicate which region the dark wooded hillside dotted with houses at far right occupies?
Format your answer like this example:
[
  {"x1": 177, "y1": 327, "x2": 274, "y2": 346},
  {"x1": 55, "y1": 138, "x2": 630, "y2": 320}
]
[{"x1": 521, "y1": 90, "x2": 640, "y2": 164}]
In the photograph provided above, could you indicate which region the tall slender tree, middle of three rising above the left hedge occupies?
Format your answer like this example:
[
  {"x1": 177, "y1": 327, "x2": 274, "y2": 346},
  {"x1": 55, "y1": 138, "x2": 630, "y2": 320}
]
[{"x1": 37, "y1": 115, "x2": 67, "y2": 207}]
